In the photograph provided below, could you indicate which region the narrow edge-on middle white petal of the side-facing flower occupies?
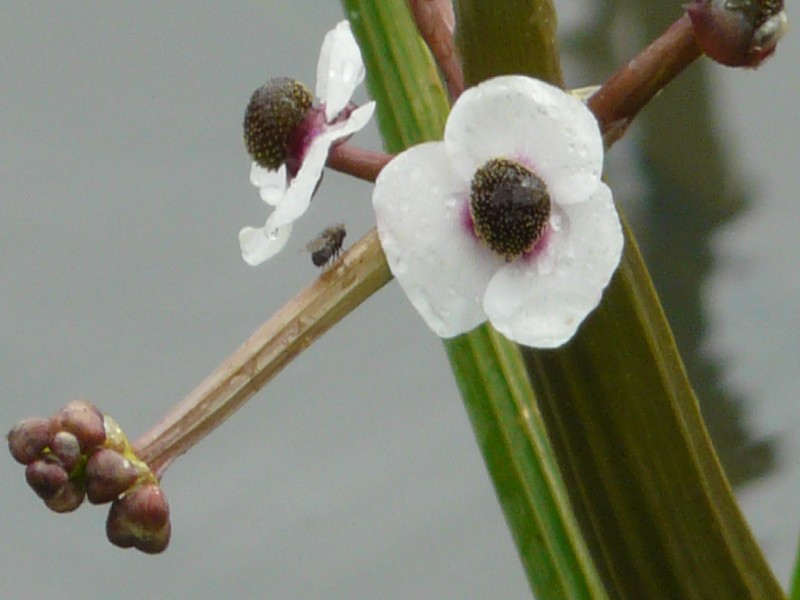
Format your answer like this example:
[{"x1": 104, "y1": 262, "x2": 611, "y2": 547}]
[{"x1": 266, "y1": 102, "x2": 375, "y2": 231}]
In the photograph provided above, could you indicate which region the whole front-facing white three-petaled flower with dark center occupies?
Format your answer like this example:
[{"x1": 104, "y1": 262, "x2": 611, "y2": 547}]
[{"x1": 372, "y1": 76, "x2": 622, "y2": 348}]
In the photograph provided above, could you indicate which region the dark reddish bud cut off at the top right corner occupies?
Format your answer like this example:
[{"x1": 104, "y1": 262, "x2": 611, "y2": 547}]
[{"x1": 686, "y1": 0, "x2": 787, "y2": 67}]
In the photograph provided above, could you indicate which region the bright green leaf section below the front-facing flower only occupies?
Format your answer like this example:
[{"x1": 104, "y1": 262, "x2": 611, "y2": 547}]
[{"x1": 445, "y1": 325, "x2": 606, "y2": 599}]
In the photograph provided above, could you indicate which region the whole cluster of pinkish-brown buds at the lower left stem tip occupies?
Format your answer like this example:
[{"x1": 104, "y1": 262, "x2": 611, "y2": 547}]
[{"x1": 7, "y1": 400, "x2": 171, "y2": 554}]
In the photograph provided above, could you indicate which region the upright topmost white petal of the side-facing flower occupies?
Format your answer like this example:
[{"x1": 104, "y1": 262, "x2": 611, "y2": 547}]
[{"x1": 316, "y1": 21, "x2": 366, "y2": 121}]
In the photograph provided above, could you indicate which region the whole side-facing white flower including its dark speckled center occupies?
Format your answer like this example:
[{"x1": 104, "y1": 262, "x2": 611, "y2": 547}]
[{"x1": 239, "y1": 21, "x2": 375, "y2": 266}]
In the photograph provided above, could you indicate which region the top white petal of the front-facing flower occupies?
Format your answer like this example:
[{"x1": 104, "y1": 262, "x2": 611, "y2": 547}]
[{"x1": 444, "y1": 75, "x2": 603, "y2": 204}]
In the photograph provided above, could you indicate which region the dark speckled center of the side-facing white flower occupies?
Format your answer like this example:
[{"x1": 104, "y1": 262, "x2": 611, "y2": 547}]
[{"x1": 244, "y1": 77, "x2": 314, "y2": 171}]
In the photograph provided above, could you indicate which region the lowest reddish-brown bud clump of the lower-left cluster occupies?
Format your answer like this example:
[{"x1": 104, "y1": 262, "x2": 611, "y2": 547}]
[{"x1": 106, "y1": 483, "x2": 172, "y2": 554}]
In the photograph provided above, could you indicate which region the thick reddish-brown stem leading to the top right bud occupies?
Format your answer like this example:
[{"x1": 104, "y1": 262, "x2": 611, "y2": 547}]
[{"x1": 588, "y1": 14, "x2": 702, "y2": 146}]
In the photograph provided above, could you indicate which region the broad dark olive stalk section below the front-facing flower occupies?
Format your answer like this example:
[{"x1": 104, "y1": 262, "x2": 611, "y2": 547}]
[{"x1": 526, "y1": 223, "x2": 784, "y2": 599}]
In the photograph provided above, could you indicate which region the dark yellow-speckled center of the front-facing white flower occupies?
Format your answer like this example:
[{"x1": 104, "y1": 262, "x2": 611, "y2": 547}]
[{"x1": 469, "y1": 158, "x2": 550, "y2": 261}]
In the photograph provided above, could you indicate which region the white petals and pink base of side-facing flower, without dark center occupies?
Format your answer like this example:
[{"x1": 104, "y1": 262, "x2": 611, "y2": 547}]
[{"x1": 239, "y1": 21, "x2": 375, "y2": 266}]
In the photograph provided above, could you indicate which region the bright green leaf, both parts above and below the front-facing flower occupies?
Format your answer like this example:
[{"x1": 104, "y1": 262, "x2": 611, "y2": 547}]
[{"x1": 343, "y1": 0, "x2": 606, "y2": 600}]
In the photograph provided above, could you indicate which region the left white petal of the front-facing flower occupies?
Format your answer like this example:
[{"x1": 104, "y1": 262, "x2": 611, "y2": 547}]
[{"x1": 372, "y1": 142, "x2": 504, "y2": 337}]
